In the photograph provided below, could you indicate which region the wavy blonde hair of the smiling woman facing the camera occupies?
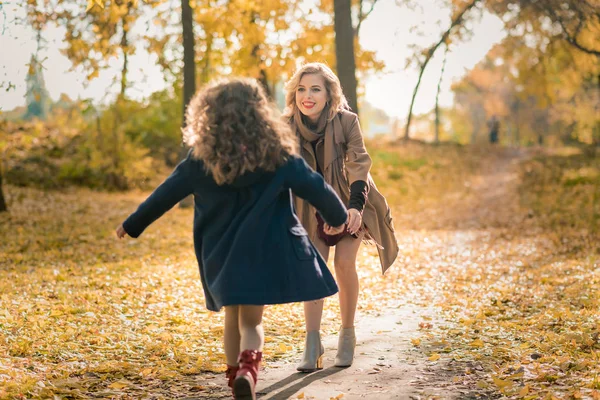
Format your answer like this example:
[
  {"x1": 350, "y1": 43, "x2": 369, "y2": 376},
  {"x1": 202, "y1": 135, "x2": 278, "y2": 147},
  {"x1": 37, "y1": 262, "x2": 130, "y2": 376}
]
[{"x1": 283, "y1": 63, "x2": 350, "y2": 119}]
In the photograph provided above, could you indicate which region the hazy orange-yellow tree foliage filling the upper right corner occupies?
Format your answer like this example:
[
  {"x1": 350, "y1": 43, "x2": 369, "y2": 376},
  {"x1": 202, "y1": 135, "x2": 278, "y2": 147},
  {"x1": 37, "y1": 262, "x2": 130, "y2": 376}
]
[{"x1": 453, "y1": 6, "x2": 600, "y2": 144}]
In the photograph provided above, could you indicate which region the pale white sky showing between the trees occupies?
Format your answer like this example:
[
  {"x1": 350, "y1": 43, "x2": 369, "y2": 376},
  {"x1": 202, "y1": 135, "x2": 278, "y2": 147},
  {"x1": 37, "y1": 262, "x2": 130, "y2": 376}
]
[{"x1": 0, "y1": 0, "x2": 504, "y2": 118}]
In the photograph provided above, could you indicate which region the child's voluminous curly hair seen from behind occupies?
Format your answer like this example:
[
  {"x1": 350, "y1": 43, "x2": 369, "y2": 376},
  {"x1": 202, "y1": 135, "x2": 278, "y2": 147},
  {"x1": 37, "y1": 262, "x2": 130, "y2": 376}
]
[{"x1": 183, "y1": 78, "x2": 298, "y2": 185}]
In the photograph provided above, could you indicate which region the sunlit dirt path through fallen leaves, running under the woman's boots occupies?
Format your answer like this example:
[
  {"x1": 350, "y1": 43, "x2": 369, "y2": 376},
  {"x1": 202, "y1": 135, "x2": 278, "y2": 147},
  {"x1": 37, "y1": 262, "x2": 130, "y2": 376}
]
[{"x1": 193, "y1": 150, "x2": 527, "y2": 400}]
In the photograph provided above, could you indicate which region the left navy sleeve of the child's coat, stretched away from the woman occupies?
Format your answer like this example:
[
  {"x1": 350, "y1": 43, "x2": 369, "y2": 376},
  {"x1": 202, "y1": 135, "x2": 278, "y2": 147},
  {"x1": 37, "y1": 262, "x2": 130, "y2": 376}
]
[{"x1": 123, "y1": 155, "x2": 193, "y2": 238}]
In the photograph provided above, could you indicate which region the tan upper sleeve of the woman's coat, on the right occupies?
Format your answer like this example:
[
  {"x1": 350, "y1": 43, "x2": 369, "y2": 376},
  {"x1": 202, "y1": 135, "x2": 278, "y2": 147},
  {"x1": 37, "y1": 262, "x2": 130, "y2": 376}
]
[{"x1": 342, "y1": 113, "x2": 372, "y2": 185}]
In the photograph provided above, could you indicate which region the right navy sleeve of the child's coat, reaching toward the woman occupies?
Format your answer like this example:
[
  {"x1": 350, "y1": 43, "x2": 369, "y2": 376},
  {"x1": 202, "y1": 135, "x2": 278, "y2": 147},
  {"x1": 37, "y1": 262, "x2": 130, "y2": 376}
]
[{"x1": 285, "y1": 156, "x2": 348, "y2": 226}]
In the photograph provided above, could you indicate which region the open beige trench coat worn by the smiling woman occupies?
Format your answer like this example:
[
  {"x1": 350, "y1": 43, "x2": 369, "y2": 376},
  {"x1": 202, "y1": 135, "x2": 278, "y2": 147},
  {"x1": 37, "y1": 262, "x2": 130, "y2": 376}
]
[{"x1": 295, "y1": 111, "x2": 398, "y2": 274}]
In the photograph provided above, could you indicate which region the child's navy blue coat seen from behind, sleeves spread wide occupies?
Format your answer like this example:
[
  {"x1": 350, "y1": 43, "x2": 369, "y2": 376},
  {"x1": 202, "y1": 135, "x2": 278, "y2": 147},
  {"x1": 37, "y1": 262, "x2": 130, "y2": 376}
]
[{"x1": 123, "y1": 152, "x2": 347, "y2": 311}]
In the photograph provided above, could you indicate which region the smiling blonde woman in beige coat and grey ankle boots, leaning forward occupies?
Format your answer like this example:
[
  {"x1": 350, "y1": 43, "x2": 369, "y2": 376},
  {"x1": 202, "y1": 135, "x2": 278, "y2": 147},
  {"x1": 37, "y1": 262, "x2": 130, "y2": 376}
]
[{"x1": 284, "y1": 63, "x2": 398, "y2": 372}]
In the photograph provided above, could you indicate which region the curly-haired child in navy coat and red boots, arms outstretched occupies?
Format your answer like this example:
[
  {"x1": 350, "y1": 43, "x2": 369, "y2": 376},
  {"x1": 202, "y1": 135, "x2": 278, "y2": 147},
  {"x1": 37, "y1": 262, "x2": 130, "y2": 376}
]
[{"x1": 117, "y1": 79, "x2": 348, "y2": 399}]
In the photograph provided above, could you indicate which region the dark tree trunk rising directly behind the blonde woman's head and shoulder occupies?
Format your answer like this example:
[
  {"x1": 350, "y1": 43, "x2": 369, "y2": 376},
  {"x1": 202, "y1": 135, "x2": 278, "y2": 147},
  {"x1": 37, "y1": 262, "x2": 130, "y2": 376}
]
[{"x1": 333, "y1": 0, "x2": 358, "y2": 113}]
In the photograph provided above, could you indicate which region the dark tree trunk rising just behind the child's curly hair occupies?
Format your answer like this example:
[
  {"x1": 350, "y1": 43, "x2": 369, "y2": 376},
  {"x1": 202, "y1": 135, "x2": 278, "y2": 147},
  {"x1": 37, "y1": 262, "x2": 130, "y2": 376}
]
[{"x1": 179, "y1": 0, "x2": 196, "y2": 208}]
